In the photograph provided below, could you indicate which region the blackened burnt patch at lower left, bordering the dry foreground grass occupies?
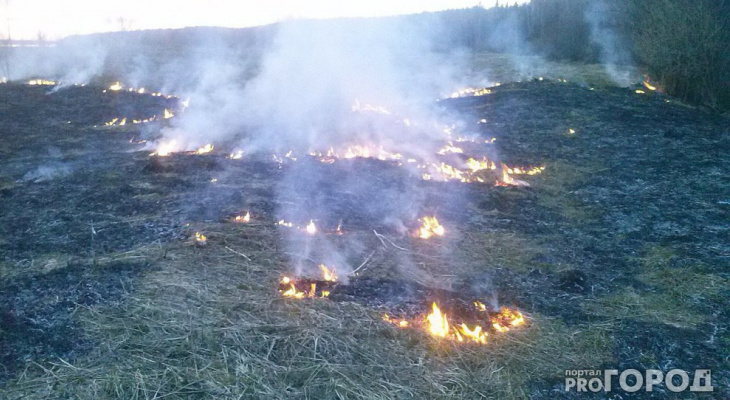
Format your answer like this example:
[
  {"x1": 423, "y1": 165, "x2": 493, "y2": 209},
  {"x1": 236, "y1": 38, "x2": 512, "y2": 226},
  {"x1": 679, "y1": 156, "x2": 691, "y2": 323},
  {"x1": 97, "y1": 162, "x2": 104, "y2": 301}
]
[{"x1": 0, "y1": 262, "x2": 149, "y2": 383}]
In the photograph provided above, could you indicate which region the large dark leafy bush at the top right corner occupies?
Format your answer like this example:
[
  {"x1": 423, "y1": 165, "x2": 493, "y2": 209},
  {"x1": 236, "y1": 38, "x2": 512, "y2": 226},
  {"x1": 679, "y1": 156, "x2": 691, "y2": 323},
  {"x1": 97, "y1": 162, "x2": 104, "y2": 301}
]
[{"x1": 633, "y1": 0, "x2": 730, "y2": 109}]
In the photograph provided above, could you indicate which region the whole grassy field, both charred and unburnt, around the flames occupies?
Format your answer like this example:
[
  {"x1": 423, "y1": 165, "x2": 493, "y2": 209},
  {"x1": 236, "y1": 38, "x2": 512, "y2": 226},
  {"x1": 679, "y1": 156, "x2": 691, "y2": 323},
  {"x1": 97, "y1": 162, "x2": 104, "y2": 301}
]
[{"x1": 0, "y1": 81, "x2": 730, "y2": 398}]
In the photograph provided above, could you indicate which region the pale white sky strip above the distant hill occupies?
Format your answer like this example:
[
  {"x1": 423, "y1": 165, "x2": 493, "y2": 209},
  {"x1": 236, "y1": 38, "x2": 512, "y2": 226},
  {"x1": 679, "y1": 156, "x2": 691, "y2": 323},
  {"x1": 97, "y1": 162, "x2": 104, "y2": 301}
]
[{"x1": 0, "y1": 0, "x2": 529, "y2": 40}]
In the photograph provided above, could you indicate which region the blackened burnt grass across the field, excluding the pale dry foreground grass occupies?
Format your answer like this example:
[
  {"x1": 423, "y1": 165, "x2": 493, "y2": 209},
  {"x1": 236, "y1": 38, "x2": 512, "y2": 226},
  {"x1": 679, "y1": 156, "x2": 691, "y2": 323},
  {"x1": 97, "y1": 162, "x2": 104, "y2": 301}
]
[{"x1": 0, "y1": 81, "x2": 730, "y2": 398}]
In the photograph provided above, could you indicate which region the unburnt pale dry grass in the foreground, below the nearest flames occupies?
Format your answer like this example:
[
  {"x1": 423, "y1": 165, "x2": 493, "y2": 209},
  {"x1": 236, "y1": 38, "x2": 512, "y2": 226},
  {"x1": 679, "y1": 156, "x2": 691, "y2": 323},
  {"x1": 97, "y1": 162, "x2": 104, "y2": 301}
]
[{"x1": 4, "y1": 225, "x2": 610, "y2": 399}]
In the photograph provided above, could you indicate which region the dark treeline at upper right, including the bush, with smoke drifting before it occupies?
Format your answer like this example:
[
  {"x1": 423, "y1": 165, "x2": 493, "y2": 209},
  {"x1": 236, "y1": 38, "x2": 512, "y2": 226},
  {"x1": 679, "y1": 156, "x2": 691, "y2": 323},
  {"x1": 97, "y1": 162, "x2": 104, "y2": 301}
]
[{"x1": 440, "y1": 0, "x2": 730, "y2": 110}]
